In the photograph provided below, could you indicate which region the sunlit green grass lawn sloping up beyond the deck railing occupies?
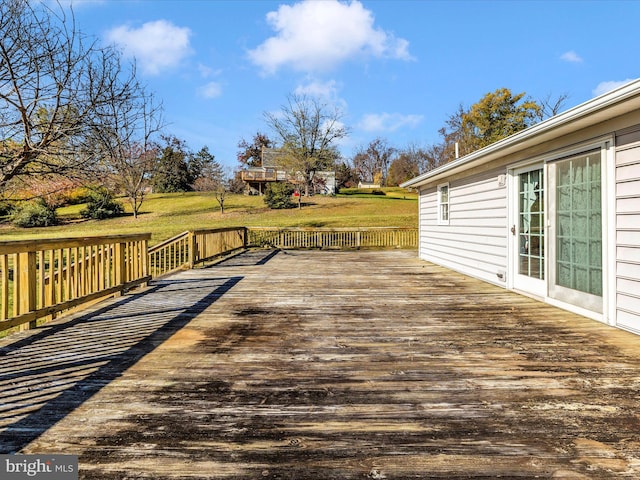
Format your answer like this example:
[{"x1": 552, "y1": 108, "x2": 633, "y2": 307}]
[{"x1": 0, "y1": 188, "x2": 418, "y2": 245}]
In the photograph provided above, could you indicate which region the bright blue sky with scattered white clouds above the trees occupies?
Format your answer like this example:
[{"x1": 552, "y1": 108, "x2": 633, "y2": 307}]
[{"x1": 70, "y1": 0, "x2": 640, "y2": 168}]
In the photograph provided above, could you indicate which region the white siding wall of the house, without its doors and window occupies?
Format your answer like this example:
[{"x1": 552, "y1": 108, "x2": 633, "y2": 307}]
[{"x1": 419, "y1": 114, "x2": 640, "y2": 334}]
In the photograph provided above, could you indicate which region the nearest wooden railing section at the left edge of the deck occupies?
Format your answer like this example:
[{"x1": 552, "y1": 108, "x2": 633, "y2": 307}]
[{"x1": 0, "y1": 234, "x2": 151, "y2": 331}]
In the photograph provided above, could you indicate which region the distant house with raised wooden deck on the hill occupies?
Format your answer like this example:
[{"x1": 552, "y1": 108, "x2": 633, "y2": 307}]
[{"x1": 240, "y1": 148, "x2": 336, "y2": 195}]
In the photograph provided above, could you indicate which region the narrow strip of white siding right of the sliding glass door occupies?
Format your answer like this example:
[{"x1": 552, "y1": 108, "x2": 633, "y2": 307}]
[{"x1": 615, "y1": 131, "x2": 640, "y2": 333}]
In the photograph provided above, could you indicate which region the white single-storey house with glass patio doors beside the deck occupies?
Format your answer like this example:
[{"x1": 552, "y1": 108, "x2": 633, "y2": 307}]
[{"x1": 401, "y1": 80, "x2": 640, "y2": 333}]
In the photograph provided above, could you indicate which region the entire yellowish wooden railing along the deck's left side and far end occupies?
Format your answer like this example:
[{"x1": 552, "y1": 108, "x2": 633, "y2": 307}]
[{"x1": 0, "y1": 227, "x2": 418, "y2": 331}]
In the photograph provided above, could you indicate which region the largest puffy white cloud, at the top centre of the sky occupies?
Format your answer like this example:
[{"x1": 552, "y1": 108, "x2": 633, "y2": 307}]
[{"x1": 248, "y1": 0, "x2": 412, "y2": 74}]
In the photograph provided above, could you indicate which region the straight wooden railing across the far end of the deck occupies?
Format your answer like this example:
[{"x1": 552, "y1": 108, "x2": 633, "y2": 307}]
[{"x1": 242, "y1": 227, "x2": 418, "y2": 249}]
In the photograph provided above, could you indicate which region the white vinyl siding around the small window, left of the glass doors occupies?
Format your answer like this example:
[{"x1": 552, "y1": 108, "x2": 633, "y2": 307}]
[{"x1": 420, "y1": 169, "x2": 507, "y2": 285}]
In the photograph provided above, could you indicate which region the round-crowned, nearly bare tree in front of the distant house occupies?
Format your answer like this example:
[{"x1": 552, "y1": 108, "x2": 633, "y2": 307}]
[{"x1": 265, "y1": 95, "x2": 348, "y2": 195}]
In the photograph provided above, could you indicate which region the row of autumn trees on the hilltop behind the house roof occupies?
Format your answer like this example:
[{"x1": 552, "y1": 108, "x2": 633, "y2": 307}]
[{"x1": 238, "y1": 88, "x2": 567, "y2": 189}]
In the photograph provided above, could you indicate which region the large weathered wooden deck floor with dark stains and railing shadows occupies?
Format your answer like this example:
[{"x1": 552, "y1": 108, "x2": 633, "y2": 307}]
[{"x1": 0, "y1": 251, "x2": 640, "y2": 480}]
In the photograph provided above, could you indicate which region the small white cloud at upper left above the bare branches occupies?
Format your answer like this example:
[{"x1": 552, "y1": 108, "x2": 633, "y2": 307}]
[{"x1": 107, "y1": 20, "x2": 191, "y2": 75}]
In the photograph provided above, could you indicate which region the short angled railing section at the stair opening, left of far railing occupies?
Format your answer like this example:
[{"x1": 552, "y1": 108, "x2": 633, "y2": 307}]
[{"x1": 149, "y1": 227, "x2": 247, "y2": 277}]
